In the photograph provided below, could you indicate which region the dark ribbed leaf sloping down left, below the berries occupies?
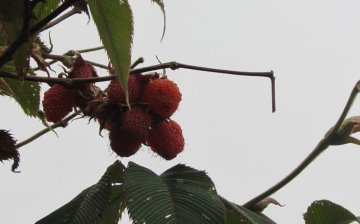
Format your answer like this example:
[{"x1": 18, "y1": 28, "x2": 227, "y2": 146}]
[{"x1": 36, "y1": 161, "x2": 122, "y2": 224}]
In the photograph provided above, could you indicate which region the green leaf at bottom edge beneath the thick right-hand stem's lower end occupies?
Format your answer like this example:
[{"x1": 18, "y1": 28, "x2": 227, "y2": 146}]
[{"x1": 225, "y1": 206, "x2": 275, "y2": 224}]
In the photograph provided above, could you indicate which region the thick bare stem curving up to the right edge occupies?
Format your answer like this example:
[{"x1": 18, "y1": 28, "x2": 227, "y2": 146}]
[{"x1": 243, "y1": 81, "x2": 360, "y2": 210}]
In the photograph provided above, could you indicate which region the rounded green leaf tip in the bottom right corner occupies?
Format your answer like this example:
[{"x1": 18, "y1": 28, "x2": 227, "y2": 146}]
[{"x1": 304, "y1": 200, "x2": 359, "y2": 224}]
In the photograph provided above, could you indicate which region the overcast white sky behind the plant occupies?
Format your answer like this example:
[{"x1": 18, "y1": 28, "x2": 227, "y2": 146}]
[{"x1": 0, "y1": 0, "x2": 360, "y2": 224}]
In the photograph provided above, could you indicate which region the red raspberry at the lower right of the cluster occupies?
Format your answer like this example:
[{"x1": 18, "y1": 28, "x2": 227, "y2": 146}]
[{"x1": 146, "y1": 120, "x2": 185, "y2": 160}]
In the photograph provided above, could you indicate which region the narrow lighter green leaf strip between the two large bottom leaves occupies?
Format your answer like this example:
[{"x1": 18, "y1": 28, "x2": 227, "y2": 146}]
[{"x1": 97, "y1": 162, "x2": 126, "y2": 224}]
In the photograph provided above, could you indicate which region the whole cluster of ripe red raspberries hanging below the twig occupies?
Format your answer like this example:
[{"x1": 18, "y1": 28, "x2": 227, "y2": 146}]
[{"x1": 43, "y1": 57, "x2": 184, "y2": 160}]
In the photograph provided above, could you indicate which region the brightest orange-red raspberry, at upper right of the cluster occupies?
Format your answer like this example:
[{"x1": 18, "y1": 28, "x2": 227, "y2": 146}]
[{"x1": 142, "y1": 79, "x2": 181, "y2": 118}]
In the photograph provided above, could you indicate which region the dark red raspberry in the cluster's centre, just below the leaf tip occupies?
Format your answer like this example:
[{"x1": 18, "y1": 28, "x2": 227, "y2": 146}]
[{"x1": 121, "y1": 106, "x2": 151, "y2": 137}]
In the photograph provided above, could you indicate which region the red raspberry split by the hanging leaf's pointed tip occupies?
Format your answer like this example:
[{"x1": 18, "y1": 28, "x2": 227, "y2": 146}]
[{"x1": 107, "y1": 74, "x2": 143, "y2": 104}]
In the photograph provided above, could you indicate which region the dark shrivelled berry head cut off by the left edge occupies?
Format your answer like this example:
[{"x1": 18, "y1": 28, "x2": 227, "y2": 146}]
[{"x1": 0, "y1": 130, "x2": 20, "y2": 171}]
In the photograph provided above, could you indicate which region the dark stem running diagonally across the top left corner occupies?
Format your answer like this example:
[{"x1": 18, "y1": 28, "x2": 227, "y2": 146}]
[{"x1": 0, "y1": 0, "x2": 77, "y2": 67}]
